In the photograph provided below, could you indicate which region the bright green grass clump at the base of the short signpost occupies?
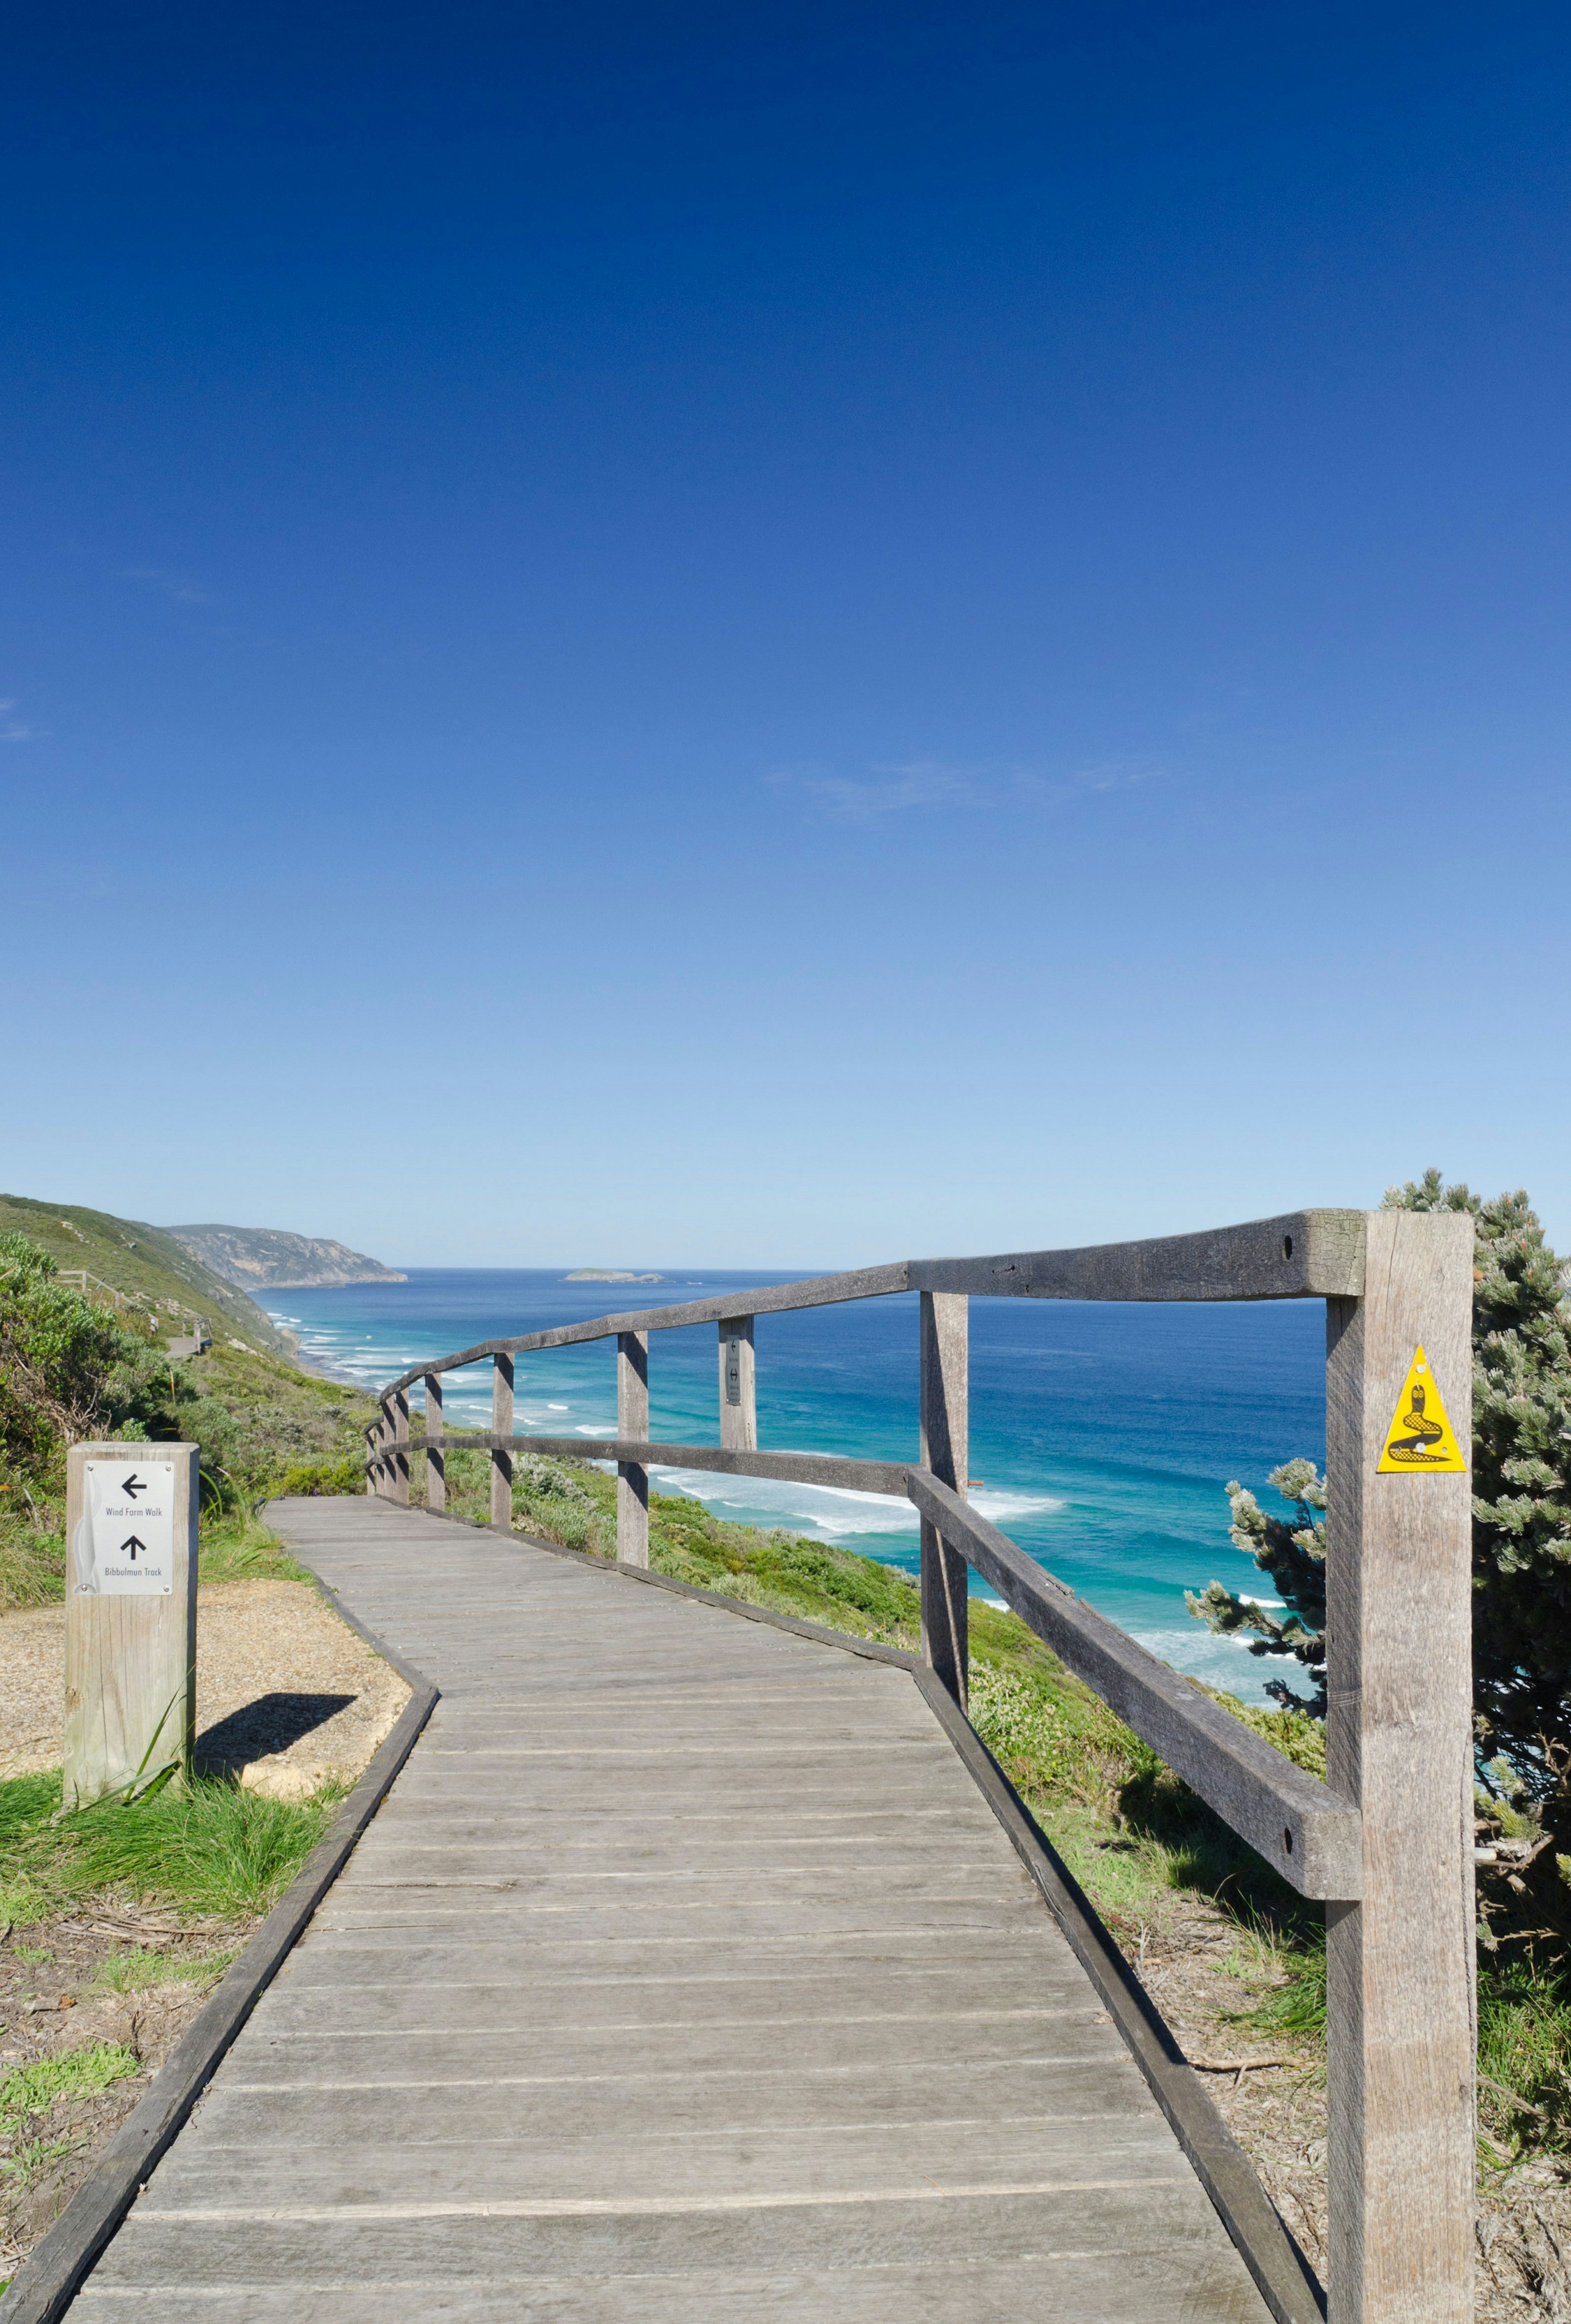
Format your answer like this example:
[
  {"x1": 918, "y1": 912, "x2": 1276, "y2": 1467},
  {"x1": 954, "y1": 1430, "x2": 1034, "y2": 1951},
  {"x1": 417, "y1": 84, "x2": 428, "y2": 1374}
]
[{"x1": 0, "y1": 1773, "x2": 337, "y2": 1927}]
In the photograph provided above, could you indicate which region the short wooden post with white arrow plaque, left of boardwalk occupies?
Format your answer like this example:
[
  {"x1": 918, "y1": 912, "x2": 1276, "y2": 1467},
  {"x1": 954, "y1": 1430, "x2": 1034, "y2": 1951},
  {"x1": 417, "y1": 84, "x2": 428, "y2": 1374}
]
[{"x1": 63, "y1": 1443, "x2": 202, "y2": 1808}]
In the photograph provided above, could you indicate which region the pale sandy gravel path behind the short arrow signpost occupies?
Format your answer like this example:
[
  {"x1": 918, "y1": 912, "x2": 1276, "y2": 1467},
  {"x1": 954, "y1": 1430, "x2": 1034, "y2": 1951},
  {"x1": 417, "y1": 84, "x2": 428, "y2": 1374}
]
[{"x1": 0, "y1": 1580, "x2": 409, "y2": 1799}]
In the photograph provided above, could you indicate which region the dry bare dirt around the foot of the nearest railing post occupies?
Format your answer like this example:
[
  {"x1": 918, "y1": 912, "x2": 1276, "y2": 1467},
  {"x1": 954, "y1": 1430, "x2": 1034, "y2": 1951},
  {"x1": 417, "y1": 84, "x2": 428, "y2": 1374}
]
[{"x1": 1116, "y1": 1896, "x2": 1571, "y2": 2324}]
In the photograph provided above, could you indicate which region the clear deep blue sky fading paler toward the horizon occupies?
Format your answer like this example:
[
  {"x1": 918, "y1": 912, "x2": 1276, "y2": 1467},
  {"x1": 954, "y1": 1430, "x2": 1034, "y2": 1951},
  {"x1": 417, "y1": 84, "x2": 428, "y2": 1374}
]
[{"x1": 0, "y1": 0, "x2": 1571, "y2": 1267}]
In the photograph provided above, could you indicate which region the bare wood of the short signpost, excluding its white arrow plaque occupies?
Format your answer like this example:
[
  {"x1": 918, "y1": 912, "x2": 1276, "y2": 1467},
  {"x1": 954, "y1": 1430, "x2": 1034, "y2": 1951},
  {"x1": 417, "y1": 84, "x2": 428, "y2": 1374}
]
[{"x1": 63, "y1": 1441, "x2": 200, "y2": 1808}]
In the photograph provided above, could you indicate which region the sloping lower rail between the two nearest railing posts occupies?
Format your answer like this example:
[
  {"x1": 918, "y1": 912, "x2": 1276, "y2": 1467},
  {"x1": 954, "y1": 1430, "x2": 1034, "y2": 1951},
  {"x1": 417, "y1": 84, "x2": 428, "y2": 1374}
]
[{"x1": 906, "y1": 1469, "x2": 1362, "y2": 1896}]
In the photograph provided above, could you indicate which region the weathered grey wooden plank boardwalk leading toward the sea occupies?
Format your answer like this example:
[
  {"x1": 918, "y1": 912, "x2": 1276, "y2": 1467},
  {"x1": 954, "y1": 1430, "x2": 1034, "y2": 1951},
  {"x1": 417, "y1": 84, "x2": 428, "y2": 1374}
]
[{"x1": 72, "y1": 1499, "x2": 1267, "y2": 2324}]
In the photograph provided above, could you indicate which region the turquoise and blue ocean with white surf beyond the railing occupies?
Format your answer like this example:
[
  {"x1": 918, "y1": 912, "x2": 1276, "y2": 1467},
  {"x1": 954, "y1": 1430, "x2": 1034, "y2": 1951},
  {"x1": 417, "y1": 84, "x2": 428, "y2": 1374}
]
[{"x1": 267, "y1": 1269, "x2": 1325, "y2": 1699}]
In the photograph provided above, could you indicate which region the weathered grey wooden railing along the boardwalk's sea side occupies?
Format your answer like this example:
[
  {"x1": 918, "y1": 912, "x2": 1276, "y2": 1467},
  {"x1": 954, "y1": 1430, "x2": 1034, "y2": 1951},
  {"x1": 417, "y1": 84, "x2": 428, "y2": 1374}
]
[{"x1": 367, "y1": 1211, "x2": 1476, "y2": 2324}]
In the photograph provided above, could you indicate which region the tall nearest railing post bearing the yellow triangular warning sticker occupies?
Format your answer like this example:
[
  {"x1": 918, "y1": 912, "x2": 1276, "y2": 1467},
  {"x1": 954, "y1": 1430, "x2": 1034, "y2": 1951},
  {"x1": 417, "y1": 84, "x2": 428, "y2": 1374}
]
[{"x1": 1325, "y1": 1211, "x2": 1476, "y2": 2324}]
